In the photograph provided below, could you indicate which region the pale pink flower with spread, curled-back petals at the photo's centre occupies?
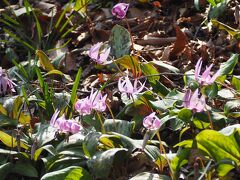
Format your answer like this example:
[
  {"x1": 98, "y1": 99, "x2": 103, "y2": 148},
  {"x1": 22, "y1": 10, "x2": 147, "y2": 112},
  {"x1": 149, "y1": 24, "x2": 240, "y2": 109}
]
[{"x1": 118, "y1": 76, "x2": 145, "y2": 95}]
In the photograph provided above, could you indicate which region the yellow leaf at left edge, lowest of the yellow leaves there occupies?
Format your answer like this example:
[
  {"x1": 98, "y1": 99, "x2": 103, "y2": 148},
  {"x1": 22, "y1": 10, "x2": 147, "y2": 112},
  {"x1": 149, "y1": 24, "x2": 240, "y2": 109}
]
[{"x1": 0, "y1": 131, "x2": 28, "y2": 150}]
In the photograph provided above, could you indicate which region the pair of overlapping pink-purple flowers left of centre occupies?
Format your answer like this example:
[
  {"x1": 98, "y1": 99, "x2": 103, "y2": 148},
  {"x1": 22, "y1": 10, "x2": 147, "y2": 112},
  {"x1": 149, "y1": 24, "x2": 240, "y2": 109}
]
[{"x1": 75, "y1": 89, "x2": 107, "y2": 115}]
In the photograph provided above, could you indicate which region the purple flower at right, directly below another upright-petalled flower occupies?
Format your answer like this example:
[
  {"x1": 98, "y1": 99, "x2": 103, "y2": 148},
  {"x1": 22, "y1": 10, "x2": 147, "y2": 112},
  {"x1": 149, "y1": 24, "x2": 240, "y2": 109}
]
[{"x1": 183, "y1": 89, "x2": 206, "y2": 112}]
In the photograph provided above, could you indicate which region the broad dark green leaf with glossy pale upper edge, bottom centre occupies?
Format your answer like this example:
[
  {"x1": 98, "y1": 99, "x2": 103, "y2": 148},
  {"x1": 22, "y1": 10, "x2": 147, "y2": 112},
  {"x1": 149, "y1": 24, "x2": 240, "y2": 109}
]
[{"x1": 87, "y1": 148, "x2": 128, "y2": 179}]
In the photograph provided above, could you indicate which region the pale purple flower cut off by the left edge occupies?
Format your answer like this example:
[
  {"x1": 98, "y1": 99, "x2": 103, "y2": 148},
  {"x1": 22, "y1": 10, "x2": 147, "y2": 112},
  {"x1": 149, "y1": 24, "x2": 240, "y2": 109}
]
[{"x1": 0, "y1": 67, "x2": 16, "y2": 94}]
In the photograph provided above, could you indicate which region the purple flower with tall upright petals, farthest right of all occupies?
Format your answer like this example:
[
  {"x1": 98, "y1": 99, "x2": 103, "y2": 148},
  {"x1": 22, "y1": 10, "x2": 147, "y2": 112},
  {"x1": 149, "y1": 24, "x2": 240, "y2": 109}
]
[{"x1": 194, "y1": 58, "x2": 220, "y2": 85}]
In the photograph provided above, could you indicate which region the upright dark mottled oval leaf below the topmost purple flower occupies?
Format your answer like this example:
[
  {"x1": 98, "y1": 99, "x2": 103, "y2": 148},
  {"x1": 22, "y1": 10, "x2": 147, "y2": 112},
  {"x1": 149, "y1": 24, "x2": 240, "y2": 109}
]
[{"x1": 109, "y1": 25, "x2": 131, "y2": 58}]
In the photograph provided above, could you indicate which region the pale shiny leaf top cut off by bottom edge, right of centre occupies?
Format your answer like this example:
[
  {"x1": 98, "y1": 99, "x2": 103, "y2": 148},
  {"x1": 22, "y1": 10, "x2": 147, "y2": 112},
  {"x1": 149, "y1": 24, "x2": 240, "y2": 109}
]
[{"x1": 129, "y1": 172, "x2": 171, "y2": 180}]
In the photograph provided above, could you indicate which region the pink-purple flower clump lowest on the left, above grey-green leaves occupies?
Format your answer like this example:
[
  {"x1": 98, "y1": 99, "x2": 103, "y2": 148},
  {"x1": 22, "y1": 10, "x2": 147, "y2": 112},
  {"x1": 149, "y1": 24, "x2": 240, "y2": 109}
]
[{"x1": 50, "y1": 110, "x2": 82, "y2": 134}]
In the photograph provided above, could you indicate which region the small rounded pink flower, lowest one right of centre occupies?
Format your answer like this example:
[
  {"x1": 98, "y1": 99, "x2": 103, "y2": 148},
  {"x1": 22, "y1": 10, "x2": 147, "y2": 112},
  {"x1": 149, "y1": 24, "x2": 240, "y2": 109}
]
[{"x1": 143, "y1": 112, "x2": 161, "y2": 130}]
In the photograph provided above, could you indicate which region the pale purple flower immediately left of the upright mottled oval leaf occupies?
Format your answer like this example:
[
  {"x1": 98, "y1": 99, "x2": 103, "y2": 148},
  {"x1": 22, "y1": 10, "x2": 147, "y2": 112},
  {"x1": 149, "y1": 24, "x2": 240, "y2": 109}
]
[{"x1": 88, "y1": 42, "x2": 111, "y2": 64}]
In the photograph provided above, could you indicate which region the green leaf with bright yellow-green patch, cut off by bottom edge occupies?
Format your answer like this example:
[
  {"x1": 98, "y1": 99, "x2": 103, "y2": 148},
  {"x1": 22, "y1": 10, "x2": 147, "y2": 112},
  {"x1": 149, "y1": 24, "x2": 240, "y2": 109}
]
[{"x1": 41, "y1": 166, "x2": 92, "y2": 180}]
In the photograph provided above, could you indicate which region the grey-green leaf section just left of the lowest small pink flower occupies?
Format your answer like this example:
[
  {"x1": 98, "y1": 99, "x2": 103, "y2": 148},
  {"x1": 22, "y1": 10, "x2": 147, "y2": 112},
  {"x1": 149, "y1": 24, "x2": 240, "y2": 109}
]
[{"x1": 104, "y1": 119, "x2": 133, "y2": 136}]
